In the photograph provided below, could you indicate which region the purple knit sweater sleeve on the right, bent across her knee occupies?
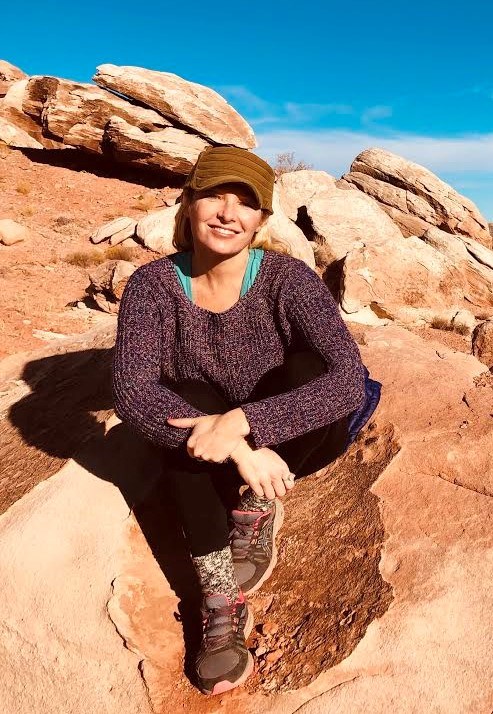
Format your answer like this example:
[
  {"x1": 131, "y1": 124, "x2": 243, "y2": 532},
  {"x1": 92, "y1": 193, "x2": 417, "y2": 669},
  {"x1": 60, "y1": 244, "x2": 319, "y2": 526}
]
[{"x1": 241, "y1": 266, "x2": 365, "y2": 448}]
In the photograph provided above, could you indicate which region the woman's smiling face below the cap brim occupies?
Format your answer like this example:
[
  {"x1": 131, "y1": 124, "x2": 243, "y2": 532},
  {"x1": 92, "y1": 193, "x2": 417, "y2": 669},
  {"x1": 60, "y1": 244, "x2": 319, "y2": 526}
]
[{"x1": 188, "y1": 183, "x2": 264, "y2": 255}]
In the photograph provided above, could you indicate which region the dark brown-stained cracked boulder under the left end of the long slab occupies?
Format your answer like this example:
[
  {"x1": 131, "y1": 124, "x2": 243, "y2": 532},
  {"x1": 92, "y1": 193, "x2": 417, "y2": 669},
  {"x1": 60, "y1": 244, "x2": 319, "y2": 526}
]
[{"x1": 23, "y1": 77, "x2": 169, "y2": 153}]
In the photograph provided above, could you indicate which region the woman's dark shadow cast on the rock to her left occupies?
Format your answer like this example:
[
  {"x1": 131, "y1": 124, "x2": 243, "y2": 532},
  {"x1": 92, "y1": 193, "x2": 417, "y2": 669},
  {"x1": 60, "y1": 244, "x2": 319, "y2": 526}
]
[{"x1": 2, "y1": 334, "x2": 201, "y2": 675}]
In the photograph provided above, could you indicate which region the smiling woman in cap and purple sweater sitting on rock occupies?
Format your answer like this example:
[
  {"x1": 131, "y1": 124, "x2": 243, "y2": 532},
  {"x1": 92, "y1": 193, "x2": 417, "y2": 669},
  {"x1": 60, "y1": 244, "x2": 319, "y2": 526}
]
[{"x1": 114, "y1": 142, "x2": 375, "y2": 694}]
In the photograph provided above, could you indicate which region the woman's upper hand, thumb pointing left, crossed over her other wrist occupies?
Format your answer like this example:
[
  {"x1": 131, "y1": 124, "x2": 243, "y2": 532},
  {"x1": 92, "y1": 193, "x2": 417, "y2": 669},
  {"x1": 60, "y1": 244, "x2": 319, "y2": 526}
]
[{"x1": 167, "y1": 409, "x2": 250, "y2": 463}]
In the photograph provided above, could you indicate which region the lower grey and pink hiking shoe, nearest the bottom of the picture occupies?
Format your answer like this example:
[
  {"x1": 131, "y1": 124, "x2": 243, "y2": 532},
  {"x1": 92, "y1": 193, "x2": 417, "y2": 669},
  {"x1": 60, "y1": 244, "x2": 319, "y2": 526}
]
[{"x1": 195, "y1": 592, "x2": 253, "y2": 694}]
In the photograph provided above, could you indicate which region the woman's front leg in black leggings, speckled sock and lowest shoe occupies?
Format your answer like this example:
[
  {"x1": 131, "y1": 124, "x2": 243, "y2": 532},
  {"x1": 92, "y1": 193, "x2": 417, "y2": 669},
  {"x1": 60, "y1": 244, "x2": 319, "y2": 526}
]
[{"x1": 165, "y1": 382, "x2": 253, "y2": 694}]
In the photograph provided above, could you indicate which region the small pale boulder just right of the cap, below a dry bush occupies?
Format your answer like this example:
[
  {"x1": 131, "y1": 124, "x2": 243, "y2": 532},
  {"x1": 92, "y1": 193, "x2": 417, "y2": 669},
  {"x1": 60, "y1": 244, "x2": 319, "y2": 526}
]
[{"x1": 277, "y1": 169, "x2": 336, "y2": 221}]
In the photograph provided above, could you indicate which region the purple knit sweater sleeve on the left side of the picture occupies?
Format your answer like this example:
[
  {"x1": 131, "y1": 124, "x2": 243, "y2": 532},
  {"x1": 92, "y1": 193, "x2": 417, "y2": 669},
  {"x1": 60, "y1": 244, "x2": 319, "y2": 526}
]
[{"x1": 113, "y1": 270, "x2": 204, "y2": 448}]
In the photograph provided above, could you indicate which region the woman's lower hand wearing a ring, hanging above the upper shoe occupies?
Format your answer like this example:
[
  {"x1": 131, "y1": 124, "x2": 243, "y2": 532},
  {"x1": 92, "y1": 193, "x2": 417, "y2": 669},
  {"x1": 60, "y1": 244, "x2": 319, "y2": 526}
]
[{"x1": 230, "y1": 439, "x2": 294, "y2": 500}]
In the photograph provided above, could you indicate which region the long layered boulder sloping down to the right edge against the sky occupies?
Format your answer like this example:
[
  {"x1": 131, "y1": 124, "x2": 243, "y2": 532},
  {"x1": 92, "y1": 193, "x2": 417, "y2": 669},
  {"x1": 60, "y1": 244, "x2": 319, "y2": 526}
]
[{"x1": 343, "y1": 148, "x2": 492, "y2": 248}]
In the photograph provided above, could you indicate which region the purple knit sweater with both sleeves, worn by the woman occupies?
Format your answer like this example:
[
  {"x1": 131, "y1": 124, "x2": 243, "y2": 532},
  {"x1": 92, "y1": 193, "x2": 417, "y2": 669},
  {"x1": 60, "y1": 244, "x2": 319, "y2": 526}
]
[{"x1": 113, "y1": 250, "x2": 365, "y2": 448}]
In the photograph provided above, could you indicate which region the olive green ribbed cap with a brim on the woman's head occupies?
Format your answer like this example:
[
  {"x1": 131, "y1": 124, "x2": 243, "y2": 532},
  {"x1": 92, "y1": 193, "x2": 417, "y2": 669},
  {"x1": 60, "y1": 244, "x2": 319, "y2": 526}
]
[{"x1": 184, "y1": 146, "x2": 275, "y2": 213}]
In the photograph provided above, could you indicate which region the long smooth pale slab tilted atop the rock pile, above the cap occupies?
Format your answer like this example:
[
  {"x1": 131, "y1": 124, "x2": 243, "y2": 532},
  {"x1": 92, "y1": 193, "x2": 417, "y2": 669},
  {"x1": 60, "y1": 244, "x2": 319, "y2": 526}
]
[{"x1": 93, "y1": 64, "x2": 256, "y2": 149}]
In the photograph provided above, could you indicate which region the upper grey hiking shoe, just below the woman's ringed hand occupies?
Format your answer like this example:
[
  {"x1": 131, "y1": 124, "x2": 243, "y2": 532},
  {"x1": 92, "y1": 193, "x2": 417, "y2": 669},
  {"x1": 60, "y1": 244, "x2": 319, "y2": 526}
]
[{"x1": 229, "y1": 499, "x2": 284, "y2": 595}]
